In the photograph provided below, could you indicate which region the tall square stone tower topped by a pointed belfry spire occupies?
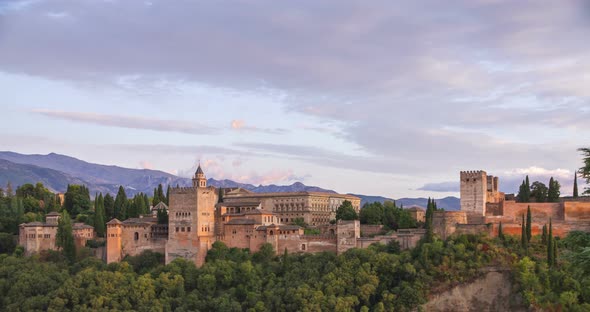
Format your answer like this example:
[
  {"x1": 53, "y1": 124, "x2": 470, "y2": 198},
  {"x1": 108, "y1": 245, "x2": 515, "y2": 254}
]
[{"x1": 166, "y1": 166, "x2": 218, "y2": 266}]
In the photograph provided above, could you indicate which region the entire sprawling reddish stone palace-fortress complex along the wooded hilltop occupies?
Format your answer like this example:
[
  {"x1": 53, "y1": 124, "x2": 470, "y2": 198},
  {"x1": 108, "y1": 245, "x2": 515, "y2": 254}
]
[{"x1": 19, "y1": 166, "x2": 590, "y2": 266}]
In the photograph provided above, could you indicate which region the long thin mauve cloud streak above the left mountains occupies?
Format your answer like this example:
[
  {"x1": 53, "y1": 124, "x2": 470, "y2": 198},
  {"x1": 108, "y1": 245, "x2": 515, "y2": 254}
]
[{"x1": 30, "y1": 109, "x2": 219, "y2": 134}]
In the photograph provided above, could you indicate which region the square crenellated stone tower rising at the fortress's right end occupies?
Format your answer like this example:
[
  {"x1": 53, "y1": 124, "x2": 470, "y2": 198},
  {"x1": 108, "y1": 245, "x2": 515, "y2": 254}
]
[{"x1": 460, "y1": 170, "x2": 490, "y2": 216}]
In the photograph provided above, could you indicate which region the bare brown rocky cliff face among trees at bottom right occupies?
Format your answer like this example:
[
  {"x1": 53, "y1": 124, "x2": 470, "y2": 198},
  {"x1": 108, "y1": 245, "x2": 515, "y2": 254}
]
[{"x1": 423, "y1": 270, "x2": 527, "y2": 312}]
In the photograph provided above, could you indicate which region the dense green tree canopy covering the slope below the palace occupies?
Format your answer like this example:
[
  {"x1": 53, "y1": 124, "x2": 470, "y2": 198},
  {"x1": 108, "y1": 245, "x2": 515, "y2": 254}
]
[{"x1": 0, "y1": 235, "x2": 528, "y2": 311}]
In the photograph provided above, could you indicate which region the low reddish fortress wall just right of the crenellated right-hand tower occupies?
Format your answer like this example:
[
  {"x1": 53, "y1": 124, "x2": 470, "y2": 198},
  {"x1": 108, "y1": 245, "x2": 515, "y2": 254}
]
[{"x1": 504, "y1": 200, "x2": 563, "y2": 223}]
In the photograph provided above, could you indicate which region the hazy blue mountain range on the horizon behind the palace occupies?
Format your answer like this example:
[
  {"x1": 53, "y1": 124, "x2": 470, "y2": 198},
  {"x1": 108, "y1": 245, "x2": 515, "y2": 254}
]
[{"x1": 0, "y1": 152, "x2": 459, "y2": 210}]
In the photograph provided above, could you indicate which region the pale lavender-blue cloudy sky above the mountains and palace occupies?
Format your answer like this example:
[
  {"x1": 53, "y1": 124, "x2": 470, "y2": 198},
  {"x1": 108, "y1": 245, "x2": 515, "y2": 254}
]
[{"x1": 0, "y1": 0, "x2": 590, "y2": 198}]
